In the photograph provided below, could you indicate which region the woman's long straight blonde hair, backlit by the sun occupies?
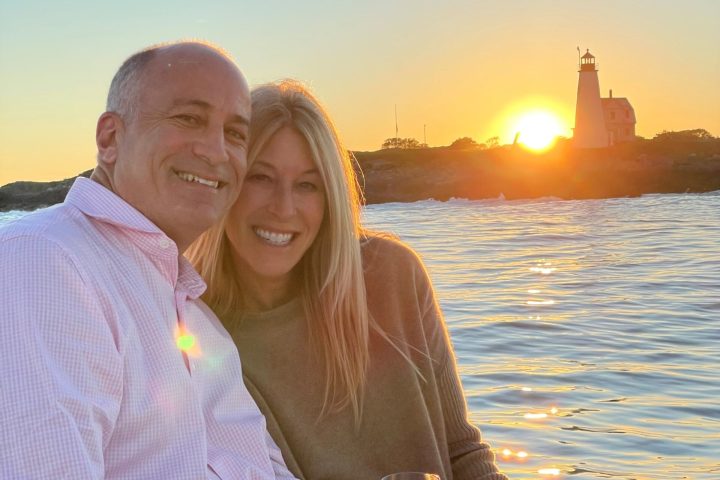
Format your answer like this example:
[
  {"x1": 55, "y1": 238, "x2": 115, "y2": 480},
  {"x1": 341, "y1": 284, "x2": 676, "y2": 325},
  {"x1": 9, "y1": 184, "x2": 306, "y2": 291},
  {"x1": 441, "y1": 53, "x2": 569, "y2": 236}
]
[{"x1": 185, "y1": 80, "x2": 372, "y2": 425}]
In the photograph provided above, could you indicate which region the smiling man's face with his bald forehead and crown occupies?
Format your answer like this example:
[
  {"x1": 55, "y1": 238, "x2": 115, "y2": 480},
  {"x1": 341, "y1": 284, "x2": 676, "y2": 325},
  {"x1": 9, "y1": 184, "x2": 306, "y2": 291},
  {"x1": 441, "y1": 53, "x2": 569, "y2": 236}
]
[{"x1": 105, "y1": 46, "x2": 250, "y2": 251}]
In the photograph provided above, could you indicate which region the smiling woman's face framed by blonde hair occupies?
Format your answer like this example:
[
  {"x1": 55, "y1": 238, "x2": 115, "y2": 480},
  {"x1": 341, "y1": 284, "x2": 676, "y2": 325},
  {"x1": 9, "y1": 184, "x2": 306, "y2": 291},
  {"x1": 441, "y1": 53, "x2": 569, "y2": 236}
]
[{"x1": 226, "y1": 127, "x2": 325, "y2": 285}]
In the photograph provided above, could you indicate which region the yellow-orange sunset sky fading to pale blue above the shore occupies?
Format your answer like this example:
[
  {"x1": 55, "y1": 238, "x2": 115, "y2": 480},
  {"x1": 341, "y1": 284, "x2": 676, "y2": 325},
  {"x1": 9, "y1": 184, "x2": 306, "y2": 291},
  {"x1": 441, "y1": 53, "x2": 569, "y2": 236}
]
[{"x1": 0, "y1": 0, "x2": 720, "y2": 185}]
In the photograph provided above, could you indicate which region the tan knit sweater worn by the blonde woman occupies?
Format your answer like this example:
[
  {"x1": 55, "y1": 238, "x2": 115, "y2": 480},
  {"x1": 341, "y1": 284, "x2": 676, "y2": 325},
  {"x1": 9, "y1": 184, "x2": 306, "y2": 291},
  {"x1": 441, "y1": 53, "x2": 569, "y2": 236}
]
[{"x1": 224, "y1": 237, "x2": 506, "y2": 480}]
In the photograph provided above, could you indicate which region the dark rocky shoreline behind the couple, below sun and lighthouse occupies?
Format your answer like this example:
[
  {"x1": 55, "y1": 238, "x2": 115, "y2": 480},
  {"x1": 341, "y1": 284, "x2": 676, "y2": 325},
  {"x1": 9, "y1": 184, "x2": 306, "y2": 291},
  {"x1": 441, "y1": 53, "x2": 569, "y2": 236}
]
[{"x1": 0, "y1": 139, "x2": 720, "y2": 211}]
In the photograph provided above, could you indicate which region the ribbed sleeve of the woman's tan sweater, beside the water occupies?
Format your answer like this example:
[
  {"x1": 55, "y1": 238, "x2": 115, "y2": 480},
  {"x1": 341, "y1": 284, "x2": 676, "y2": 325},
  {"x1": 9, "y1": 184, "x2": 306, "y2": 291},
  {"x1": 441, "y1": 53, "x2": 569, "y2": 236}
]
[{"x1": 417, "y1": 264, "x2": 507, "y2": 480}]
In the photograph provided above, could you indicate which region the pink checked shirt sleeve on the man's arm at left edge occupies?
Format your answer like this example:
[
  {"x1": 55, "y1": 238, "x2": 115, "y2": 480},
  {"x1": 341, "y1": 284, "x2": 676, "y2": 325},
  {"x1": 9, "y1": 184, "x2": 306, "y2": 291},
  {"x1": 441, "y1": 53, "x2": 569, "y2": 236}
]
[{"x1": 0, "y1": 236, "x2": 123, "y2": 479}]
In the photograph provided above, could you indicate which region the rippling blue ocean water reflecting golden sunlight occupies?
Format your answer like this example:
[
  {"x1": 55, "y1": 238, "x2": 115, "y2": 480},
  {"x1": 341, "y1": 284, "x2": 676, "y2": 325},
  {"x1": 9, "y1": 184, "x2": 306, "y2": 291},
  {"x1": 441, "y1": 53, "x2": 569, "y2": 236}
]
[{"x1": 0, "y1": 192, "x2": 720, "y2": 480}]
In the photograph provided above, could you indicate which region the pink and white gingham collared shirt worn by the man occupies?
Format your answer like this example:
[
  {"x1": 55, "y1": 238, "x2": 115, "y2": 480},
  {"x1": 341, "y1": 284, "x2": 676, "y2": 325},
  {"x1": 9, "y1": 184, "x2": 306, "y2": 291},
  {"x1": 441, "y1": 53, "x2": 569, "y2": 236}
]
[{"x1": 0, "y1": 178, "x2": 293, "y2": 480}]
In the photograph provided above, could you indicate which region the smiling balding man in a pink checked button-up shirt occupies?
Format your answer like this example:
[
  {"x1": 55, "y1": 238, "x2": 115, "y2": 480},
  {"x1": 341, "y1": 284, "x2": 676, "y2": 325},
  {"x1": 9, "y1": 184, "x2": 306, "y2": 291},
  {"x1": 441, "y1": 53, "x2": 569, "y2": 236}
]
[{"x1": 0, "y1": 42, "x2": 292, "y2": 480}]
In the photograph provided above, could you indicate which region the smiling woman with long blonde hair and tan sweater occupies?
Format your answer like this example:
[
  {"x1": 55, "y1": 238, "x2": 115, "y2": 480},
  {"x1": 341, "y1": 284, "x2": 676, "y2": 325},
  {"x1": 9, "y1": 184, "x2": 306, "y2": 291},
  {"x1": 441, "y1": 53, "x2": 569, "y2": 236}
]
[{"x1": 188, "y1": 81, "x2": 505, "y2": 480}]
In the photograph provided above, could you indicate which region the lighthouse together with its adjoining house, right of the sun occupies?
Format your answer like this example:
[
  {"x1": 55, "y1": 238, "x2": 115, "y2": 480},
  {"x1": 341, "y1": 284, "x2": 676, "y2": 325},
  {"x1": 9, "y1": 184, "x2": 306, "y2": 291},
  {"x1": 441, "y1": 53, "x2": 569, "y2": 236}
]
[{"x1": 573, "y1": 49, "x2": 636, "y2": 148}]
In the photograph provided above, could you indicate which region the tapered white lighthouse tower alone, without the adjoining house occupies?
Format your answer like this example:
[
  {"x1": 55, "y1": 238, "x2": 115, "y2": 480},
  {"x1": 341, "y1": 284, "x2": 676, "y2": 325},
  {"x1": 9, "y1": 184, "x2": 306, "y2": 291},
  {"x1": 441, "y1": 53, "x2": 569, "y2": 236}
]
[{"x1": 573, "y1": 50, "x2": 608, "y2": 148}]
